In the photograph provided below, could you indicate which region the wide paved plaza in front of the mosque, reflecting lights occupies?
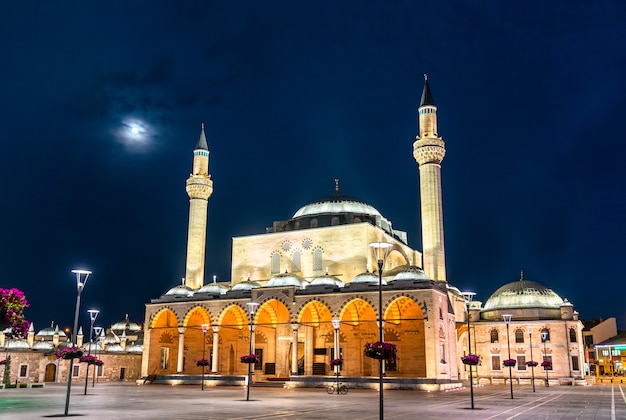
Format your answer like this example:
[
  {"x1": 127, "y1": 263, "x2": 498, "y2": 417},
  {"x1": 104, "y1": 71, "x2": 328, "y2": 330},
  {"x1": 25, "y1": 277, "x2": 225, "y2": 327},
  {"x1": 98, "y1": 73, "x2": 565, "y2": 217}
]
[{"x1": 0, "y1": 383, "x2": 626, "y2": 420}]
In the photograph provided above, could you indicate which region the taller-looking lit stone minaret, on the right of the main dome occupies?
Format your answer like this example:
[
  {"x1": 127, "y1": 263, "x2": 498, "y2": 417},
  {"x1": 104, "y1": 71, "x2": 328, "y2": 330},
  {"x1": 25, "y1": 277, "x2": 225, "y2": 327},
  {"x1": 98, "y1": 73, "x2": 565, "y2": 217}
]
[{"x1": 413, "y1": 75, "x2": 446, "y2": 281}]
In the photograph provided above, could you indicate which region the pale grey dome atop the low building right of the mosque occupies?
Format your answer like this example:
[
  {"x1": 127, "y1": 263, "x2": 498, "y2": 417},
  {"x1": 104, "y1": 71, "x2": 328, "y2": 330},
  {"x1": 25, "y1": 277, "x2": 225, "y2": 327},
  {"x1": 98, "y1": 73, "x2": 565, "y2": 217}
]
[{"x1": 484, "y1": 278, "x2": 563, "y2": 310}]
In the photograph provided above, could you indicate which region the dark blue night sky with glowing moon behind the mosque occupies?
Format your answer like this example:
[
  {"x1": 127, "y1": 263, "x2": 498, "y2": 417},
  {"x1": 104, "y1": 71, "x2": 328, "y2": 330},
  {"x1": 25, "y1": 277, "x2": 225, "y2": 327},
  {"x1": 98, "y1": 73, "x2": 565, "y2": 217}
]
[{"x1": 0, "y1": 0, "x2": 626, "y2": 330}]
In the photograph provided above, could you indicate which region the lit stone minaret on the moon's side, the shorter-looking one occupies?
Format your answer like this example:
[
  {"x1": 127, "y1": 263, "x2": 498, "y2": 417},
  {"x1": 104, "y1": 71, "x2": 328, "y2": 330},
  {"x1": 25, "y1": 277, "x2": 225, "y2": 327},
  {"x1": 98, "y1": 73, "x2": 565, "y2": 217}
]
[{"x1": 185, "y1": 123, "x2": 213, "y2": 289}]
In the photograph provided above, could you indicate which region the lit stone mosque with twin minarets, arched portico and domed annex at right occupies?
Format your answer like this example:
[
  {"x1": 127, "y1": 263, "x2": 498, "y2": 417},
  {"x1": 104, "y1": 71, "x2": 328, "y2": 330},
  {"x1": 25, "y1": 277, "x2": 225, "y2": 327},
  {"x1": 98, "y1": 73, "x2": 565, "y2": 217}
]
[{"x1": 141, "y1": 77, "x2": 585, "y2": 390}]
